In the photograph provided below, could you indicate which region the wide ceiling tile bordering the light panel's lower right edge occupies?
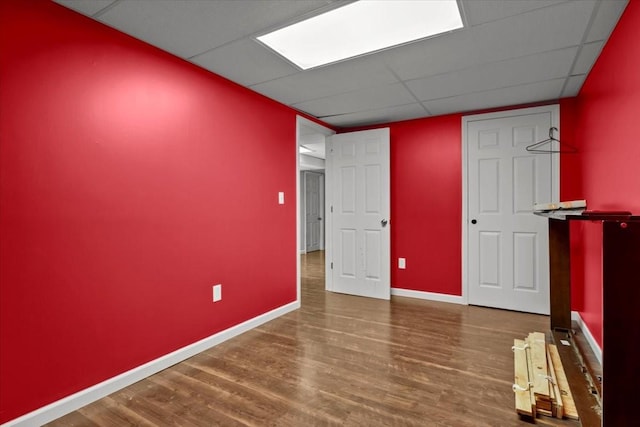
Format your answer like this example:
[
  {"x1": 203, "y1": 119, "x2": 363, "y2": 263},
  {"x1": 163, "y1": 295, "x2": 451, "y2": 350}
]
[{"x1": 378, "y1": 0, "x2": 595, "y2": 80}]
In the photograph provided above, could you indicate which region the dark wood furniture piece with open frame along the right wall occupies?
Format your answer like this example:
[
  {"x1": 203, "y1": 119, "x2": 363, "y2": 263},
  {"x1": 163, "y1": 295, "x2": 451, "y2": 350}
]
[{"x1": 536, "y1": 210, "x2": 640, "y2": 426}]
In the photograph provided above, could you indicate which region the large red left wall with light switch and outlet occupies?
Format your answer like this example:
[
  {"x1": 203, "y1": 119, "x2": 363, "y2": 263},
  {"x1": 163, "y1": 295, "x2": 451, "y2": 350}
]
[{"x1": 0, "y1": 0, "x2": 296, "y2": 423}]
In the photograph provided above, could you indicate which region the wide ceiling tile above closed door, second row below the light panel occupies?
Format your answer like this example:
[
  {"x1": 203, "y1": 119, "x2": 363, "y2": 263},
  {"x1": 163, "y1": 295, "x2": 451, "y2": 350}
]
[{"x1": 407, "y1": 47, "x2": 578, "y2": 101}]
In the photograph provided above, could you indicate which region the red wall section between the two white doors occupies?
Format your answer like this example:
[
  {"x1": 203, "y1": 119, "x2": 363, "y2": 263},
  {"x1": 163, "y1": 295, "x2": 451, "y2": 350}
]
[{"x1": 388, "y1": 114, "x2": 462, "y2": 295}]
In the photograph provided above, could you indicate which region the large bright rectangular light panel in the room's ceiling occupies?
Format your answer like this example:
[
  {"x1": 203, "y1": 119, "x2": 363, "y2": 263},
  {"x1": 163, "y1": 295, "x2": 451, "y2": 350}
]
[{"x1": 258, "y1": 0, "x2": 463, "y2": 70}]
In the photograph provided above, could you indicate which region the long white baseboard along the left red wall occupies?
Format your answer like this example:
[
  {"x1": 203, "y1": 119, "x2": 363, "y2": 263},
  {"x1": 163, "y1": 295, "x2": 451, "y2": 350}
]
[{"x1": 2, "y1": 301, "x2": 300, "y2": 427}]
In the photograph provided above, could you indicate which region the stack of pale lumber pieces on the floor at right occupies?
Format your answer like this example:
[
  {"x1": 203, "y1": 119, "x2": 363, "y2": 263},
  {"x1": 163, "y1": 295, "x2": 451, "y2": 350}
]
[{"x1": 512, "y1": 332, "x2": 578, "y2": 422}]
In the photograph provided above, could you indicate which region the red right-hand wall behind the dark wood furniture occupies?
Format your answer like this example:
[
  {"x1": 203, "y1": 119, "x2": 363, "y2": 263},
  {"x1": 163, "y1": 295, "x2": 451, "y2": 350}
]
[{"x1": 572, "y1": 0, "x2": 640, "y2": 346}]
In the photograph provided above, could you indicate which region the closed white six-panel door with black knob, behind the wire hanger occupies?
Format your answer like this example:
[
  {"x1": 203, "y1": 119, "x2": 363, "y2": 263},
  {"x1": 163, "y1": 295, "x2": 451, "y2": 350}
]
[{"x1": 464, "y1": 106, "x2": 559, "y2": 314}]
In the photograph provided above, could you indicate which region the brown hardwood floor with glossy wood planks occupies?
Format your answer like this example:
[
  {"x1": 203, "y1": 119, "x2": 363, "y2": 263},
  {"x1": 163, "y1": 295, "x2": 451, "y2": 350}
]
[{"x1": 49, "y1": 252, "x2": 579, "y2": 427}]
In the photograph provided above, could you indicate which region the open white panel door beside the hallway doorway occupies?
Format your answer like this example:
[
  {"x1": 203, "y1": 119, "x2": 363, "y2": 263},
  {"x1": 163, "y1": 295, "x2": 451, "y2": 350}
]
[{"x1": 326, "y1": 128, "x2": 391, "y2": 299}]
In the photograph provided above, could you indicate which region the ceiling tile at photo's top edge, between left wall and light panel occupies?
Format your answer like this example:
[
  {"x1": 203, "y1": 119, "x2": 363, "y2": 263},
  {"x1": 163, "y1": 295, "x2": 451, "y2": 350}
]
[{"x1": 99, "y1": 0, "x2": 338, "y2": 58}]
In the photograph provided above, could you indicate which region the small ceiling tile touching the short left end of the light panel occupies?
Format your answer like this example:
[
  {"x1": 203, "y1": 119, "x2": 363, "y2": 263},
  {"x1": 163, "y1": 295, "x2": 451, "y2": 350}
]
[{"x1": 191, "y1": 38, "x2": 299, "y2": 86}]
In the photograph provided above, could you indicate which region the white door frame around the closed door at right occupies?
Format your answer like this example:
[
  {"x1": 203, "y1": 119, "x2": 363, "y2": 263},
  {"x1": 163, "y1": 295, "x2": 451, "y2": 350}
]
[{"x1": 461, "y1": 104, "x2": 561, "y2": 304}]
